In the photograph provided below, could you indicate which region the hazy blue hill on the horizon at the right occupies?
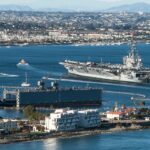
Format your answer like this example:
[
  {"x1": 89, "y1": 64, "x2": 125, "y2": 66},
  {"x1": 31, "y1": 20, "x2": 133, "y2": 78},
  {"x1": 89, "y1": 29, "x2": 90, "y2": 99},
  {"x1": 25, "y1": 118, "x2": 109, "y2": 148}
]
[{"x1": 105, "y1": 3, "x2": 150, "y2": 12}]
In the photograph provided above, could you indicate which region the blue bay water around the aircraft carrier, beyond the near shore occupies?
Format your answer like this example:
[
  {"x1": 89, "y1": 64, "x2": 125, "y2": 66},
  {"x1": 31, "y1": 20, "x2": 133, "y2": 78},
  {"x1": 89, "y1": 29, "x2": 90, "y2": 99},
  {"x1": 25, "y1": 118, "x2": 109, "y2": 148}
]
[{"x1": 0, "y1": 44, "x2": 150, "y2": 109}]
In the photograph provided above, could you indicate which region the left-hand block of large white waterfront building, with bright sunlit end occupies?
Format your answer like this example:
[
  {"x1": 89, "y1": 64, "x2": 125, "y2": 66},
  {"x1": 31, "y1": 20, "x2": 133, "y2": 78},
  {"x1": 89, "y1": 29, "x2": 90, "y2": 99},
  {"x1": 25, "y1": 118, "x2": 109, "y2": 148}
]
[{"x1": 45, "y1": 109, "x2": 79, "y2": 132}]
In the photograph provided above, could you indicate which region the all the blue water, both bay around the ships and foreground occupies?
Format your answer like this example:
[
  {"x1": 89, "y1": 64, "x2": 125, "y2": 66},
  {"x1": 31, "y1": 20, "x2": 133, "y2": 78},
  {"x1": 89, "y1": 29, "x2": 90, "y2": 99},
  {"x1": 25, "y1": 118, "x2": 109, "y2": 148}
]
[{"x1": 0, "y1": 44, "x2": 150, "y2": 150}]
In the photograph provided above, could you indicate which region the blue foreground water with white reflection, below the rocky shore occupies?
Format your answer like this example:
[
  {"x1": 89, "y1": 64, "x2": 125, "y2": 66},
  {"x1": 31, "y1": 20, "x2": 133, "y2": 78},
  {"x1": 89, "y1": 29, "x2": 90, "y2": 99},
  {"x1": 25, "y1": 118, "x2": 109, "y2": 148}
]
[{"x1": 0, "y1": 130, "x2": 150, "y2": 150}]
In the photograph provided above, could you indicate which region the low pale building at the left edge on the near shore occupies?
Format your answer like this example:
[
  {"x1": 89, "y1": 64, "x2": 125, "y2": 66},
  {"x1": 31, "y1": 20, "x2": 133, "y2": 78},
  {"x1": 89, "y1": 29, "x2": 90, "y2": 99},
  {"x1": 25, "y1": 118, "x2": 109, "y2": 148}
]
[{"x1": 0, "y1": 119, "x2": 19, "y2": 131}]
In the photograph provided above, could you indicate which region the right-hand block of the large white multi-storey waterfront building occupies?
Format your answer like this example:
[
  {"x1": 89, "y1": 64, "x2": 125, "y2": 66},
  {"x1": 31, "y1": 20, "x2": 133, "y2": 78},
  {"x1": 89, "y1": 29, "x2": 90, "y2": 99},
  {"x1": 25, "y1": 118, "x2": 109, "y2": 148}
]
[{"x1": 78, "y1": 109, "x2": 100, "y2": 128}]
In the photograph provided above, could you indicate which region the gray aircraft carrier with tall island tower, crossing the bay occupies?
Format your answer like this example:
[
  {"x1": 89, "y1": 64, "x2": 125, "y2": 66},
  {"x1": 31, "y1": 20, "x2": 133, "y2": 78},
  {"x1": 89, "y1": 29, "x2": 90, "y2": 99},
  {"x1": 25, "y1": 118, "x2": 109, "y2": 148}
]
[{"x1": 60, "y1": 43, "x2": 150, "y2": 83}]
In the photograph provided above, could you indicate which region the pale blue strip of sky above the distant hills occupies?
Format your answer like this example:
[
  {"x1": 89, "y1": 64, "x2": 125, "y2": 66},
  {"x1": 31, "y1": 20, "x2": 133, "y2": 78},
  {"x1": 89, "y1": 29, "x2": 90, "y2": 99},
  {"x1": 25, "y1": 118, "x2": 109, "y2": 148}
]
[{"x1": 0, "y1": 0, "x2": 150, "y2": 10}]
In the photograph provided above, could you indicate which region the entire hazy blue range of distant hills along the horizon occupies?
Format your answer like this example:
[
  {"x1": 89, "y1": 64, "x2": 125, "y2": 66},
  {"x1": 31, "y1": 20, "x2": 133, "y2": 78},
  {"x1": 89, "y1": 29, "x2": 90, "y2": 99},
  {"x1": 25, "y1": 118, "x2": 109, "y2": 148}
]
[{"x1": 0, "y1": 3, "x2": 150, "y2": 13}]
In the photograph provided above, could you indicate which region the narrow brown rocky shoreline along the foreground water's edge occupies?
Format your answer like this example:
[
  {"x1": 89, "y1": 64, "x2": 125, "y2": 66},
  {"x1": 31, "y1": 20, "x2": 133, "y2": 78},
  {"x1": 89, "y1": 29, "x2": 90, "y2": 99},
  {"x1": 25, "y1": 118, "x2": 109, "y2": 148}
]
[{"x1": 0, "y1": 125, "x2": 150, "y2": 144}]
